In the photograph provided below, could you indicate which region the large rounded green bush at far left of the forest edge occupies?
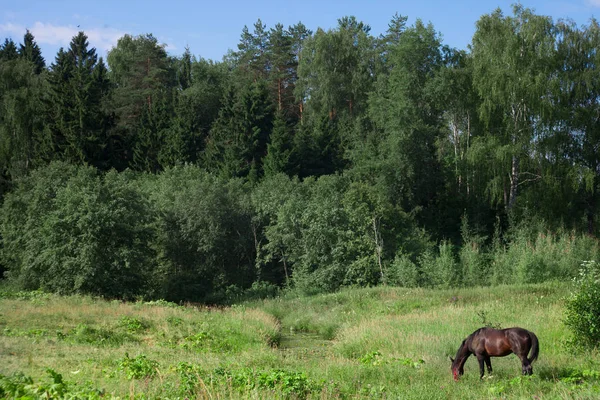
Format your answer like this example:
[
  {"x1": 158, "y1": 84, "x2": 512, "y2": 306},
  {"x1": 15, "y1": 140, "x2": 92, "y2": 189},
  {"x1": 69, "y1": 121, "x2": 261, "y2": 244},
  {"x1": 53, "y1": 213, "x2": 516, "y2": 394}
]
[{"x1": 0, "y1": 163, "x2": 153, "y2": 298}]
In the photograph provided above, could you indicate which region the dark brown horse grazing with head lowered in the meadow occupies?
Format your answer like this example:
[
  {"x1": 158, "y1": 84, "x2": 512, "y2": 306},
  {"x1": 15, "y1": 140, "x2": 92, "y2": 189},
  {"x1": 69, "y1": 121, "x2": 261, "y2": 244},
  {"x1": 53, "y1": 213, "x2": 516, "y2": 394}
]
[{"x1": 450, "y1": 328, "x2": 540, "y2": 381}]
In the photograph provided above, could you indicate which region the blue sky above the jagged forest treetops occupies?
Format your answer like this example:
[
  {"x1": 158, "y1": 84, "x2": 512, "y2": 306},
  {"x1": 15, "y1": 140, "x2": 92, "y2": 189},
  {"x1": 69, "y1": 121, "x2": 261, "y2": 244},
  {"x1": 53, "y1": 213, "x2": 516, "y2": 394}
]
[{"x1": 0, "y1": 0, "x2": 600, "y2": 64}]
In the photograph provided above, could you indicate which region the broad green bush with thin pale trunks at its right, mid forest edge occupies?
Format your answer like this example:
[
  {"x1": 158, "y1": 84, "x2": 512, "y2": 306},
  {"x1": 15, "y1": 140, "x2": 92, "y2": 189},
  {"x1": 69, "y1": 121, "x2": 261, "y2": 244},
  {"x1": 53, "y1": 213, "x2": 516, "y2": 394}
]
[{"x1": 252, "y1": 175, "x2": 427, "y2": 294}]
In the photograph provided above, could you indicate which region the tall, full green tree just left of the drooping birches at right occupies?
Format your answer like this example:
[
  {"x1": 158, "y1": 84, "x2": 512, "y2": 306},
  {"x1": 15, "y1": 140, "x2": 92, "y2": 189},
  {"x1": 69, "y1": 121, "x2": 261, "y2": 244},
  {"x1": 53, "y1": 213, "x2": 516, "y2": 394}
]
[{"x1": 363, "y1": 20, "x2": 442, "y2": 218}]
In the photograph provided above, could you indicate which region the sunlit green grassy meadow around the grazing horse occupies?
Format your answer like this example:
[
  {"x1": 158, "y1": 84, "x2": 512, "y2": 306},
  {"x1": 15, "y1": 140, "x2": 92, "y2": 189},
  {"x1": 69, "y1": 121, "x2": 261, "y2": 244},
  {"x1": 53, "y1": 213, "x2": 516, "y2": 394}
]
[{"x1": 0, "y1": 283, "x2": 600, "y2": 399}]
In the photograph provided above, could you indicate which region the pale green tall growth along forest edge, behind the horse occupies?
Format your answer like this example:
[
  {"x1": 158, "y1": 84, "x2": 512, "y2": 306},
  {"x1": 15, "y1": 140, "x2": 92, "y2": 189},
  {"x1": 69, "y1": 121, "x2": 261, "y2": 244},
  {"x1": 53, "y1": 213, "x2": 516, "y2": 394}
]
[{"x1": 408, "y1": 227, "x2": 600, "y2": 289}]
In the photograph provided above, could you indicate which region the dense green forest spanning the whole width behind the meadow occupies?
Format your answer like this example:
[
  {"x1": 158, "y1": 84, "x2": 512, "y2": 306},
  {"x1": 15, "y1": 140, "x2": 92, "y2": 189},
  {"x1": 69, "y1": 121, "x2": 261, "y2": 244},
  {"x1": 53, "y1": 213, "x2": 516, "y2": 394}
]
[{"x1": 0, "y1": 5, "x2": 600, "y2": 304}]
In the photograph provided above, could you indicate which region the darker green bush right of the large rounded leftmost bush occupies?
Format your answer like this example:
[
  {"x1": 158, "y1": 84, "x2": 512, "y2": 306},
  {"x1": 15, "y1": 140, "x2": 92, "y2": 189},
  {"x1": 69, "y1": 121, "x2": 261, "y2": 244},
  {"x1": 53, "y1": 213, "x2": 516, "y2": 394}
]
[{"x1": 147, "y1": 165, "x2": 256, "y2": 303}]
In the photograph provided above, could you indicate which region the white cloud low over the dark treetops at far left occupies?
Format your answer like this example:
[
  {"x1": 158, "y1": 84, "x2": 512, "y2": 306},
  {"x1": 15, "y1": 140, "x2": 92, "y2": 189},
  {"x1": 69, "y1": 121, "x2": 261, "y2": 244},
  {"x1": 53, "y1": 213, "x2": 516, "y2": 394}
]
[{"x1": 0, "y1": 21, "x2": 125, "y2": 52}]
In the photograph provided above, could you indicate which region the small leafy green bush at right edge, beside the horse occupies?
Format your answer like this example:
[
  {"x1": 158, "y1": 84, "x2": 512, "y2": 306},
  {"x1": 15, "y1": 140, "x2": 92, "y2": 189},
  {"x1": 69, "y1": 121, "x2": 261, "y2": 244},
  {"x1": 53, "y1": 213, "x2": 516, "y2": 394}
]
[{"x1": 565, "y1": 261, "x2": 600, "y2": 347}]
